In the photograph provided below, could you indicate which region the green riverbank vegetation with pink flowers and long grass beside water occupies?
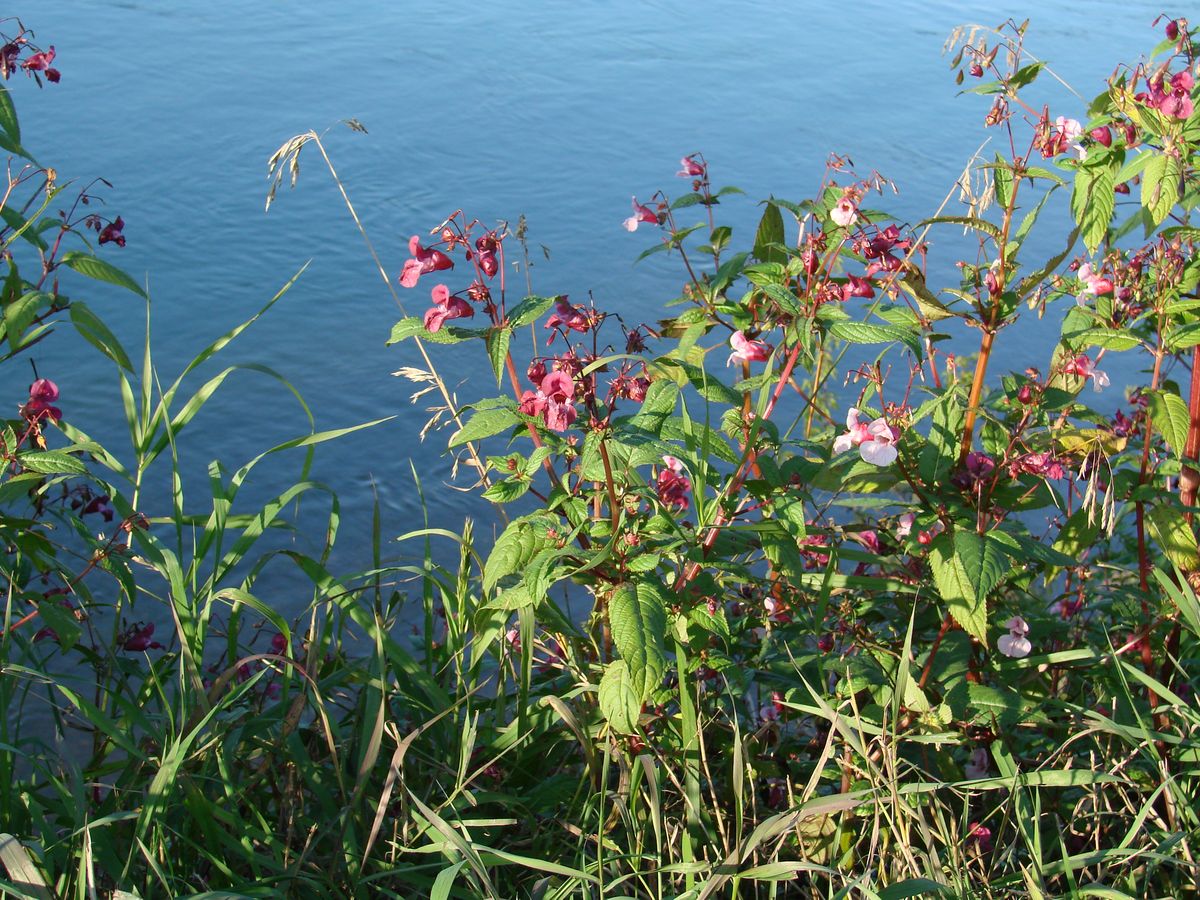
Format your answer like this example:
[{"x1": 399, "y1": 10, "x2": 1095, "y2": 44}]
[{"x1": 0, "y1": 18, "x2": 1200, "y2": 900}]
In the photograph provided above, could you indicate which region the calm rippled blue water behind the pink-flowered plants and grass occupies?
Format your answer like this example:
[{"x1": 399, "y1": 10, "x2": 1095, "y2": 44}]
[{"x1": 0, "y1": 0, "x2": 1160, "y2": 605}]
